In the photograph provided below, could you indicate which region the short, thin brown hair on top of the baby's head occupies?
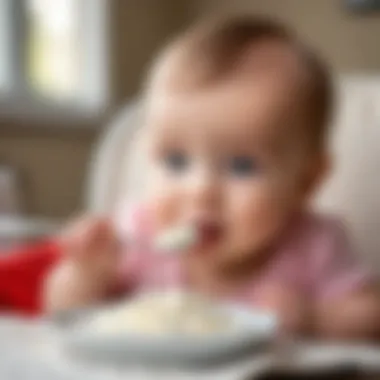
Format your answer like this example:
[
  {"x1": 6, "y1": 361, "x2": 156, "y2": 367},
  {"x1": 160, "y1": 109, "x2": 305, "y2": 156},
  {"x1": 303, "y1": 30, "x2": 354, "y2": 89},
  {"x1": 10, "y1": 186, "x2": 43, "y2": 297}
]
[{"x1": 148, "y1": 15, "x2": 333, "y2": 151}]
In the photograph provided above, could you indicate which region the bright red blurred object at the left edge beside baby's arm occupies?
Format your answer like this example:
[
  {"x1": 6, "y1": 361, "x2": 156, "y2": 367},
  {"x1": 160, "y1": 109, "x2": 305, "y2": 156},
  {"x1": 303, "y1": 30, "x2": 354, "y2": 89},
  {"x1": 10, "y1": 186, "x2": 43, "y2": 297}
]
[{"x1": 0, "y1": 241, "x2": 60, "y2": 316}]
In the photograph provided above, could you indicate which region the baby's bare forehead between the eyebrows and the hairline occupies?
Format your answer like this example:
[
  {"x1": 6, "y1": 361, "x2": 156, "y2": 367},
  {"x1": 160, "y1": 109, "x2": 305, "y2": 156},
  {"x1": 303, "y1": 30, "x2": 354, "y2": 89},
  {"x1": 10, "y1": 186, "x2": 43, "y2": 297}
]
[{"x1": 145, "y1": 46, "x2": 304, "y2": 148}]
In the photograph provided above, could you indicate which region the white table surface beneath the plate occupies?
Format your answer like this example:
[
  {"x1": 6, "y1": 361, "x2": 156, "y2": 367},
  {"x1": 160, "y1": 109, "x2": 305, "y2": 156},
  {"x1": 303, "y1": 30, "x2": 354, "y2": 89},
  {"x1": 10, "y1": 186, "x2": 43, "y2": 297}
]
[{"x1": 0, "y1": 317, "x2": 380, "y2": 380}]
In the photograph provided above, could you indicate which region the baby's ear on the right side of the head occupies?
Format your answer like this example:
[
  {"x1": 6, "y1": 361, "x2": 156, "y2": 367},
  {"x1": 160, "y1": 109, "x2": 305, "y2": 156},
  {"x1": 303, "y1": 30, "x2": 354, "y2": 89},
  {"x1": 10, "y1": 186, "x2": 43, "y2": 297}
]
[{"x1": 303, "y1": 152, "x2": 332, "y2": 198}]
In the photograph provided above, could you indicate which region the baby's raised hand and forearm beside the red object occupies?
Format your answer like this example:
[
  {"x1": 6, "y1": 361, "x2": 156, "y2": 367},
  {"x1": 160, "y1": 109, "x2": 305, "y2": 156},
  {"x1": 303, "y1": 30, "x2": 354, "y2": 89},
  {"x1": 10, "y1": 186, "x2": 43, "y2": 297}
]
[{"x1": 44, "y1": 218, "x2": 120, "y2": 312}]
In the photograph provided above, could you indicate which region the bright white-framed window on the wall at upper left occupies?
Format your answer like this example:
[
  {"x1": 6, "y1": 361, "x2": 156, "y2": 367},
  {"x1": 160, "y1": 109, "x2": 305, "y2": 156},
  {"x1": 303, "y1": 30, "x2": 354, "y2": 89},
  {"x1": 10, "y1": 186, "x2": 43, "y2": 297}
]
[{"x1": 0, "y1": 0, "x2": 108, "y2": 121}]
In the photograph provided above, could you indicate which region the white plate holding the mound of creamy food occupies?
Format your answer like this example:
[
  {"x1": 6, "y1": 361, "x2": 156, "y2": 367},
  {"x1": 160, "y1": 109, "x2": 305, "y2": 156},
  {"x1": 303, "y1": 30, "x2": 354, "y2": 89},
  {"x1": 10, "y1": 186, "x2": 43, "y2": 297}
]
[{"x1": 55, "y1": 305, "x2": 277, "y2": 365}]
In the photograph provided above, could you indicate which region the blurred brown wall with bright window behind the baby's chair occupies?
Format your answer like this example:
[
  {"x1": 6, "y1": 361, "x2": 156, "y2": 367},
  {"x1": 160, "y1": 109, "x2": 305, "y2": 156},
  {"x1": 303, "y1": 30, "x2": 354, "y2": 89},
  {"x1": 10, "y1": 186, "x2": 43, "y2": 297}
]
[{"x1": 0, "y1": 0, "x2": 380, "y2": 218}]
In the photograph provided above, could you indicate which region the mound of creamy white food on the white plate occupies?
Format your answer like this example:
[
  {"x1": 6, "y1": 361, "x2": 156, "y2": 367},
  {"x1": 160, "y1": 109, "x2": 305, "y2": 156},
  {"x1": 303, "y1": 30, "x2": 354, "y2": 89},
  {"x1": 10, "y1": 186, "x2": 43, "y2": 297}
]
[{"x1": 91, "y1": 291, "x2": 236, "y2": 335}]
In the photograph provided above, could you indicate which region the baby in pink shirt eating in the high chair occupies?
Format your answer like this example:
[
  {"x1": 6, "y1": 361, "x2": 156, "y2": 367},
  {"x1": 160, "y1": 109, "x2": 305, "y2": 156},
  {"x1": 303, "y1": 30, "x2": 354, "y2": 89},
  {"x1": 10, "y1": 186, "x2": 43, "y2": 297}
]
[{"x1": 45, "y1": 16, "x2": 380, "y2": 340}]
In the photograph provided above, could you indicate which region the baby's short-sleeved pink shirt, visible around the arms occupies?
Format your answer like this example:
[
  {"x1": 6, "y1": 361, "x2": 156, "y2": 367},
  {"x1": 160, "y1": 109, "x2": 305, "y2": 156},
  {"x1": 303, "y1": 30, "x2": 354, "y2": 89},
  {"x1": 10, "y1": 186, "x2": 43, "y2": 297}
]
[{"x1": 117, "y1": 203, "x2": 371, "y2": 303}]
